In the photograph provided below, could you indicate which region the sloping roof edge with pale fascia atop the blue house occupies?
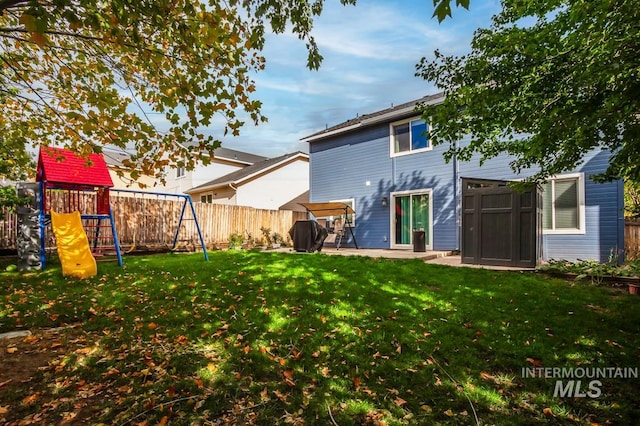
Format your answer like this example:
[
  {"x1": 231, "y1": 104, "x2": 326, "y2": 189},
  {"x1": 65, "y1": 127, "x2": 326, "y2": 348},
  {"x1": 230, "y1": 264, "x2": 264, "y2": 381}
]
[{"x1": 301, "y1": 93, "x2": 444, "y2": 143}]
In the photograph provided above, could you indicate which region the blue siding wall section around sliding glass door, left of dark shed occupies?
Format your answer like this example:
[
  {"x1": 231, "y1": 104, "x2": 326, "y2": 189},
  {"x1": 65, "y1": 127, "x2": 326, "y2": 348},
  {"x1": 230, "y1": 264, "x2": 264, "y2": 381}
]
[{"x1": 310, "y1": 124, "x2": 458, "y2": 250}]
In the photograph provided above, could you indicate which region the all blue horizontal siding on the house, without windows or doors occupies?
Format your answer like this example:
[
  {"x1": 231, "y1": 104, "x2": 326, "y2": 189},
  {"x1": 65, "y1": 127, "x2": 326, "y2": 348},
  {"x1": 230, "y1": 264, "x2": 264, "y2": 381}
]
[{"x1": 309, "y1": 99, "x2": 624, "y2": 261}]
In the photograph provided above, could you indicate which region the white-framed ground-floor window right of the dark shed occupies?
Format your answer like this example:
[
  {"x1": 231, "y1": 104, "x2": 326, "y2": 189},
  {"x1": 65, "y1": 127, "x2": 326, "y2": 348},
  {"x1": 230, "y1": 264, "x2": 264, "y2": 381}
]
[{"x1": 542, "y1": 173, "x2": 585, "y2": 234}]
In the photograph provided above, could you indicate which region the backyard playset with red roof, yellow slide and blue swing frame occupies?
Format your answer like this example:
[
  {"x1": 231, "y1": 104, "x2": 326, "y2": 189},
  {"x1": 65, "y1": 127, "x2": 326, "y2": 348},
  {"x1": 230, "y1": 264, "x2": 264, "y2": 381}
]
[{"x1": 18, "y1": 147, "x2": 208, "y2": 278}]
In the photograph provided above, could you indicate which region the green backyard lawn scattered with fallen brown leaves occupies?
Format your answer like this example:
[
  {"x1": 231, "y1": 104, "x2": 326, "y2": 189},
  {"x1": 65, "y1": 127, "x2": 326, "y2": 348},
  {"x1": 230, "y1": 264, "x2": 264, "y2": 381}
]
[{"x1": 0, "y1": 251, "x2": 640, "y2": 425}]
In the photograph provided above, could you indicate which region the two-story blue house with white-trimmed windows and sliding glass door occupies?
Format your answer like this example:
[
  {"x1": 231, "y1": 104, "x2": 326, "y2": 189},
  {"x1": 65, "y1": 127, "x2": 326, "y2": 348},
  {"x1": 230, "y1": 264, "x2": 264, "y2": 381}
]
[{"x1": 302, "y1": 94, "x2": 624, "y2": 261}]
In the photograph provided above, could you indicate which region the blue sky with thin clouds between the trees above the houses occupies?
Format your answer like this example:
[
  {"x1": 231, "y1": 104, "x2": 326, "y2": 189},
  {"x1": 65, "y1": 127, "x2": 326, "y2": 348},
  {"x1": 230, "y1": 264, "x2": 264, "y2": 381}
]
[{"x1": 218, "y1": 0, "x2": 500, "y2": 157}]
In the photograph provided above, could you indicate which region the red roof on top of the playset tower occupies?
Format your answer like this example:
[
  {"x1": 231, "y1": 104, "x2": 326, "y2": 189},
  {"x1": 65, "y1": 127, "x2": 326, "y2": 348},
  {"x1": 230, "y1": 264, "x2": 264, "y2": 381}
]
[{"x1": 36, "y1": 146, "x2": 113, "y2": 188}]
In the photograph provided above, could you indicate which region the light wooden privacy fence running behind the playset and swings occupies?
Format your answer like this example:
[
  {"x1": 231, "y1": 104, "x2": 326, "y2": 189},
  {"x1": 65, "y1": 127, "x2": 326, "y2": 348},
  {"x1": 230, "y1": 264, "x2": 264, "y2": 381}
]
[{"x1": 0, "y1": 194, "x2": 307, "y2": 251}]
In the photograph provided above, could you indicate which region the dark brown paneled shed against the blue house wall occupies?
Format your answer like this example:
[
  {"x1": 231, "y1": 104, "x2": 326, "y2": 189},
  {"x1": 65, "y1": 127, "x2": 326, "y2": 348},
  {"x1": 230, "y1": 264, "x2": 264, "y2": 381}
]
[{"x1": 461, "y1": 178, "x2": 542, "y2": 267}]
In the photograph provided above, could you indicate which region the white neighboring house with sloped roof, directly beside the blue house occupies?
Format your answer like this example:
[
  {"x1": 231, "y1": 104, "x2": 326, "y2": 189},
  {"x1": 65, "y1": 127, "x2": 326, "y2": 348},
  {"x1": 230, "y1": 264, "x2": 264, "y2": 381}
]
[{"x1": 185, "y1": 152, "x2": 309, "y2": 210}]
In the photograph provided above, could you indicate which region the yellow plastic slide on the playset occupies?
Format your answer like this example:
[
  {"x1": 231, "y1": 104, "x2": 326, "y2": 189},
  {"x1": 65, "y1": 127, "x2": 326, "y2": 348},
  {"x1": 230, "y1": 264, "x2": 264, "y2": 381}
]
[{"x1": 51, "y1": 210, "x2": 98, "y2": 278}]
